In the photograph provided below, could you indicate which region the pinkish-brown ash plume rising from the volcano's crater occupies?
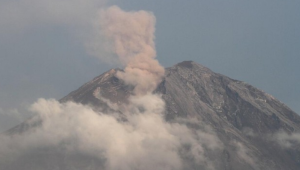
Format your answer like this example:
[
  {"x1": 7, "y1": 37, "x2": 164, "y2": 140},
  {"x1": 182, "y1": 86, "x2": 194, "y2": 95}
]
[{"x1": 100, "y1": 6, "x2": 164, "y2": 95}]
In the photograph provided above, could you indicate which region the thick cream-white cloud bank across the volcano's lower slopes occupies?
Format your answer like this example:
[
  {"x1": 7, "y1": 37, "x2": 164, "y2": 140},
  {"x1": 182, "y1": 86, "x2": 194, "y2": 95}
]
[{"x1": 0, "y1": 95, "x2": 224, "y2": 170}]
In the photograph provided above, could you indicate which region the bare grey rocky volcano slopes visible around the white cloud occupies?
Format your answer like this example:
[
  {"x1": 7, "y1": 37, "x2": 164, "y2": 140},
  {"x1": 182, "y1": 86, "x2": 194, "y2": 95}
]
[{"x1": 61, "y1": 61, "x2": 300, "y2": 170}]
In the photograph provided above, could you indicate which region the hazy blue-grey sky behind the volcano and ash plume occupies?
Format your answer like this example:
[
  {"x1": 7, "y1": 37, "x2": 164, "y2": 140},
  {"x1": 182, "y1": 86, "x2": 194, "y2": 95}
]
[{"x1": 0, "y1": 0, "x2": 300, "y2": 131}]
